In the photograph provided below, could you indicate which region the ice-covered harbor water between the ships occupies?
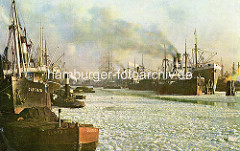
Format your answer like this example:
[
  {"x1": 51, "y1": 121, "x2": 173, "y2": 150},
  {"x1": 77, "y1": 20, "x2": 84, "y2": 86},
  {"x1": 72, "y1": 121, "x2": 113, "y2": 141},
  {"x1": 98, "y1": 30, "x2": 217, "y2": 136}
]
[{"x1": 53, "y1": 89, "x2": 240, "y2": 151}]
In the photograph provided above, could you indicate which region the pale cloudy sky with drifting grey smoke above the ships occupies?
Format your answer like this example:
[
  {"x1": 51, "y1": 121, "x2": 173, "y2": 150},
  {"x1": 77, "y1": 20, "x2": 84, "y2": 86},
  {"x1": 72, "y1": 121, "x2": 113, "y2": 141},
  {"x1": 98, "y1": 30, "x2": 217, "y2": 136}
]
[{"x1": 0, "y1": 0, "x2": 240, "y2": 71}]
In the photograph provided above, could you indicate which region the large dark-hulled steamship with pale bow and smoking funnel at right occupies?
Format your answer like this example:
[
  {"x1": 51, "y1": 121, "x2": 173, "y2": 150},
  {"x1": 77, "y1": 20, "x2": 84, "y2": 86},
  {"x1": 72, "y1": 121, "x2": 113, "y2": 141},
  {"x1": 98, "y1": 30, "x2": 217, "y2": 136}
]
[{"x1": 156, "y1": 30, "x2": 221, "y2": 95}]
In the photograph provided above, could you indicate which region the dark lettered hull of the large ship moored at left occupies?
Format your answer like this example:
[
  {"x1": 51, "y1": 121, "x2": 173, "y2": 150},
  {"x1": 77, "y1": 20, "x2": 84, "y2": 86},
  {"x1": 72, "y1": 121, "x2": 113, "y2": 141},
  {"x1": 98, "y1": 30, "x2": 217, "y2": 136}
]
[{"x1": 0, "y1": 76, "x2": 51, "y2": 114}]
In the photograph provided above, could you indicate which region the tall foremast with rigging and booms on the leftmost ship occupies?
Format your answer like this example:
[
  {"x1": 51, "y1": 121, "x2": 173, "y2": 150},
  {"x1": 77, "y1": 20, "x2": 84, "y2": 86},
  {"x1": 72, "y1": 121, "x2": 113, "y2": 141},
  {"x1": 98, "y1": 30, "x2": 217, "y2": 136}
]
[{"x1": 4, "y1": 0, "x2": 31, "y2": 78}]
